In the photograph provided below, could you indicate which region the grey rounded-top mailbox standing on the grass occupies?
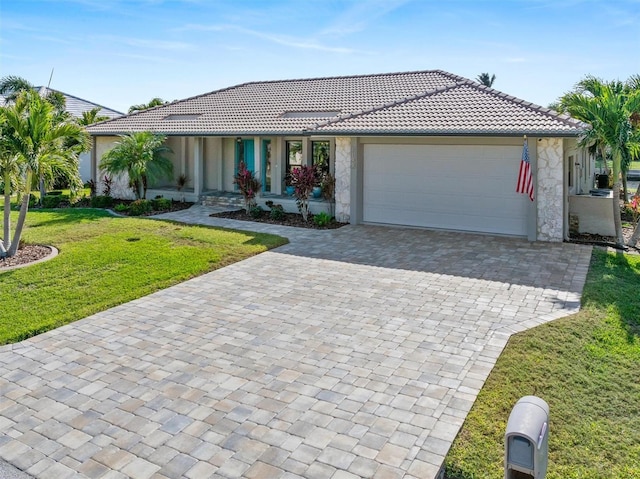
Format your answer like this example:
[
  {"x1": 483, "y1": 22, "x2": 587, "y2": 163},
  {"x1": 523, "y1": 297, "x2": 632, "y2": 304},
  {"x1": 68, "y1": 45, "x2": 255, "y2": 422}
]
[{"x1": 504, "y1": 396, "x2": 549, "y2": 479}]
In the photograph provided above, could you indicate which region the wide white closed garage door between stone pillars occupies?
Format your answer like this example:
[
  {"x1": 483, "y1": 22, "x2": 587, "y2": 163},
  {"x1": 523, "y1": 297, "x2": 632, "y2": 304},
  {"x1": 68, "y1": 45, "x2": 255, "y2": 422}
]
[{"x1": 363, "y1": 145, "x2": 530, "y2": 236}]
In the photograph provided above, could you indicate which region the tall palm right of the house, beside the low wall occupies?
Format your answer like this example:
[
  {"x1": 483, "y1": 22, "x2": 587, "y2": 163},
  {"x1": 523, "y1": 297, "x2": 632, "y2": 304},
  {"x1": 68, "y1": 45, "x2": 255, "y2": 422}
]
[{"x1": 561, "y1": 77, "x2": 640, "y2": 247}]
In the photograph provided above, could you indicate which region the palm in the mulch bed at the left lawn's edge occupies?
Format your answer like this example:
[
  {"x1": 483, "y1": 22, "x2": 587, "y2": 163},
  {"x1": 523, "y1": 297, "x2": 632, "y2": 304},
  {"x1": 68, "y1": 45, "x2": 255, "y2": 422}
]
[{"x1": 0, "y1": 90, "x2": 88, "y2": 256}]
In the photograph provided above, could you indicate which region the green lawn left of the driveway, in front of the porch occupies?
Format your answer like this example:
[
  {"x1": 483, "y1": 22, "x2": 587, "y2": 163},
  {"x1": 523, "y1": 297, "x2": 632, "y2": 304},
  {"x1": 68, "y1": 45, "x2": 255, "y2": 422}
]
[{"x1": 0, "y1": 208, "x2": 286, "y2": 344}]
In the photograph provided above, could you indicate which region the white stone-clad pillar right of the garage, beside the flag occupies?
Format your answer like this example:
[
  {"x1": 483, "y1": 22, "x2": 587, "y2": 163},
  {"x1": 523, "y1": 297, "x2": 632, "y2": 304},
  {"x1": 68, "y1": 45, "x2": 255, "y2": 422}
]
[{"x1": 536, "y1": 138, "x2": 564, "y2": 241}]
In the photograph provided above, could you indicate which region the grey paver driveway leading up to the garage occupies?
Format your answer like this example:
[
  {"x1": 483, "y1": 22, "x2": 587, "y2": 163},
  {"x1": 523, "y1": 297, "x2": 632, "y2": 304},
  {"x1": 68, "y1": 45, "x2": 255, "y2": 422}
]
[{"x1": 0, "y1": 208, "x2": 591, "y2": 479}]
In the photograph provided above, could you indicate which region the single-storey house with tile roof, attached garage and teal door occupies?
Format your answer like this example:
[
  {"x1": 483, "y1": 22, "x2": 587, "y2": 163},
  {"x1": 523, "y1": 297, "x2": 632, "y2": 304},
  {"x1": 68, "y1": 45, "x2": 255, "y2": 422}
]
[{"x1": 88, "y1": 70, "x2": 592, "y2": 241}]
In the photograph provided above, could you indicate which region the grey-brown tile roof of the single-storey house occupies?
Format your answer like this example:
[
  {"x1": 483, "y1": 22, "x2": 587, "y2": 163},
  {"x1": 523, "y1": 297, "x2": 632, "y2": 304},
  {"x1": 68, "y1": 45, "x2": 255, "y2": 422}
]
[{"x1": 88, "y1": 70, "x2": 584, "y2": 136}]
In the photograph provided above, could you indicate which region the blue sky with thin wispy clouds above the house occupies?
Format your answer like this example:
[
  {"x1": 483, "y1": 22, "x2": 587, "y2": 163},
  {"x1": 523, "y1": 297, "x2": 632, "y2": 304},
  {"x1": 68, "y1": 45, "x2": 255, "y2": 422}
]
[{"x1": 0, "y1": 0, "x2": 640, "y2": 111}]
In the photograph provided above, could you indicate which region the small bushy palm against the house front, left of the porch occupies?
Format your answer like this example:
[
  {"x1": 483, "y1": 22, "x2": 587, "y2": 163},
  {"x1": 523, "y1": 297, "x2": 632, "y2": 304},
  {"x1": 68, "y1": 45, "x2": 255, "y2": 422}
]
[{"x1": 100, "y1": 131, "x2": 173, "y2": 199}]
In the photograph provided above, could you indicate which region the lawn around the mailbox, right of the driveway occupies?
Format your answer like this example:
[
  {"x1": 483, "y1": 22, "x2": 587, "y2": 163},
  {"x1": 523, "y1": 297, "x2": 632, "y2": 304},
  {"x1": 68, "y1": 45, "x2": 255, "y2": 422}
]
[{"x1": 445, "y1": 251, "x2": 640, "y2": 479}]
